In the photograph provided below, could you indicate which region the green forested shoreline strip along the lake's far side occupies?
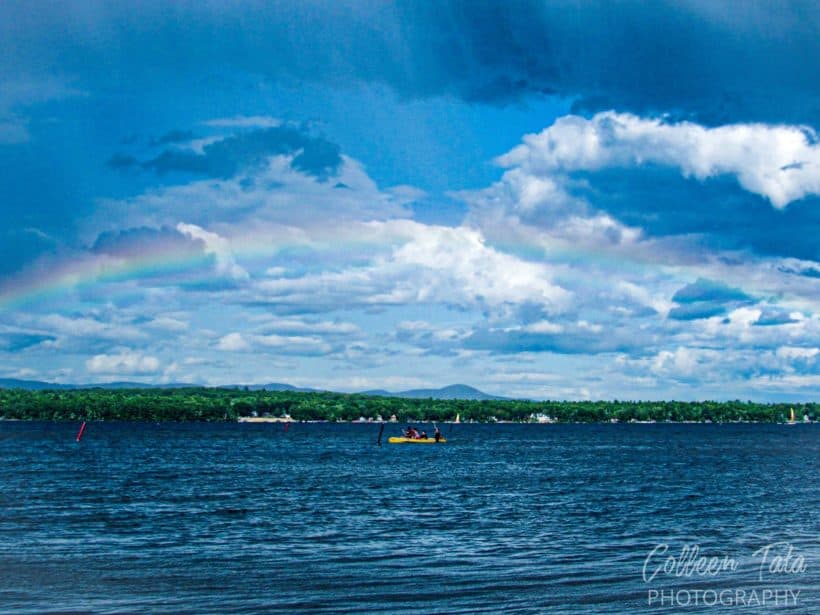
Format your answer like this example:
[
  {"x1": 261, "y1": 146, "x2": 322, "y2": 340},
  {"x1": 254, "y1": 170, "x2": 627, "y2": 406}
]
[{"x1": 0, "y1": 387, "x2": 820, "y2": 423}]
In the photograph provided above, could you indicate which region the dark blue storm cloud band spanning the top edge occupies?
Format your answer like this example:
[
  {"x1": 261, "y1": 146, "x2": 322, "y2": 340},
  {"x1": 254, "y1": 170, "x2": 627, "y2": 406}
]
[{"x1": 0, "y1": 0, "x2": 820, "y2": 123}]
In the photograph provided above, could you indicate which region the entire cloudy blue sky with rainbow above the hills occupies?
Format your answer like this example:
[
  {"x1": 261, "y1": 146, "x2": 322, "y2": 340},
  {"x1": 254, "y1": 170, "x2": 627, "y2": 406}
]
[{"x1": 0, "y1": 0, "x2": 820, "y2": 401}]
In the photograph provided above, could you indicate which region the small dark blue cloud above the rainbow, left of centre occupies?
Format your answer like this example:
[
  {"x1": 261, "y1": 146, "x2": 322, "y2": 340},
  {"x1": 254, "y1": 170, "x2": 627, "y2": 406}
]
[{"x1": 142, "y1": 126, "x2": 342, "y2": 179}]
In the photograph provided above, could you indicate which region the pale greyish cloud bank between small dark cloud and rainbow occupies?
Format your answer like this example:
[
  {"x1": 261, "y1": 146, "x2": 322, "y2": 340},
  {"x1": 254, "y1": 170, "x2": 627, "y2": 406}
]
[{"x1": 94, "y1": 156, "x2": 410, "y2": 233}]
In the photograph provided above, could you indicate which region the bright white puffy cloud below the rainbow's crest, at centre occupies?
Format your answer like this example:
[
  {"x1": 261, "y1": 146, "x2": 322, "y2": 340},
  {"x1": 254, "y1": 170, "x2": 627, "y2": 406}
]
[{"x1": 255, "y1": 221, "x2": 571, "y2": 312}]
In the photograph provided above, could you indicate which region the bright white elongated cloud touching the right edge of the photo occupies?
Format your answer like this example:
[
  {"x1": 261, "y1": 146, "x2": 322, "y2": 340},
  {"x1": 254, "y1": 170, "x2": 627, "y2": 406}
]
[{"x1": 498, "y1": 111, "x2": 820, "y2": 208}]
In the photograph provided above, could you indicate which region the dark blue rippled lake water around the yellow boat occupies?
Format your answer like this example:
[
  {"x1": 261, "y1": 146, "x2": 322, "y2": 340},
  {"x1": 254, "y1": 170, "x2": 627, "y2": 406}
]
[{"x1": 0, "y1": 422, "x2": 820, "y2": 613}]
